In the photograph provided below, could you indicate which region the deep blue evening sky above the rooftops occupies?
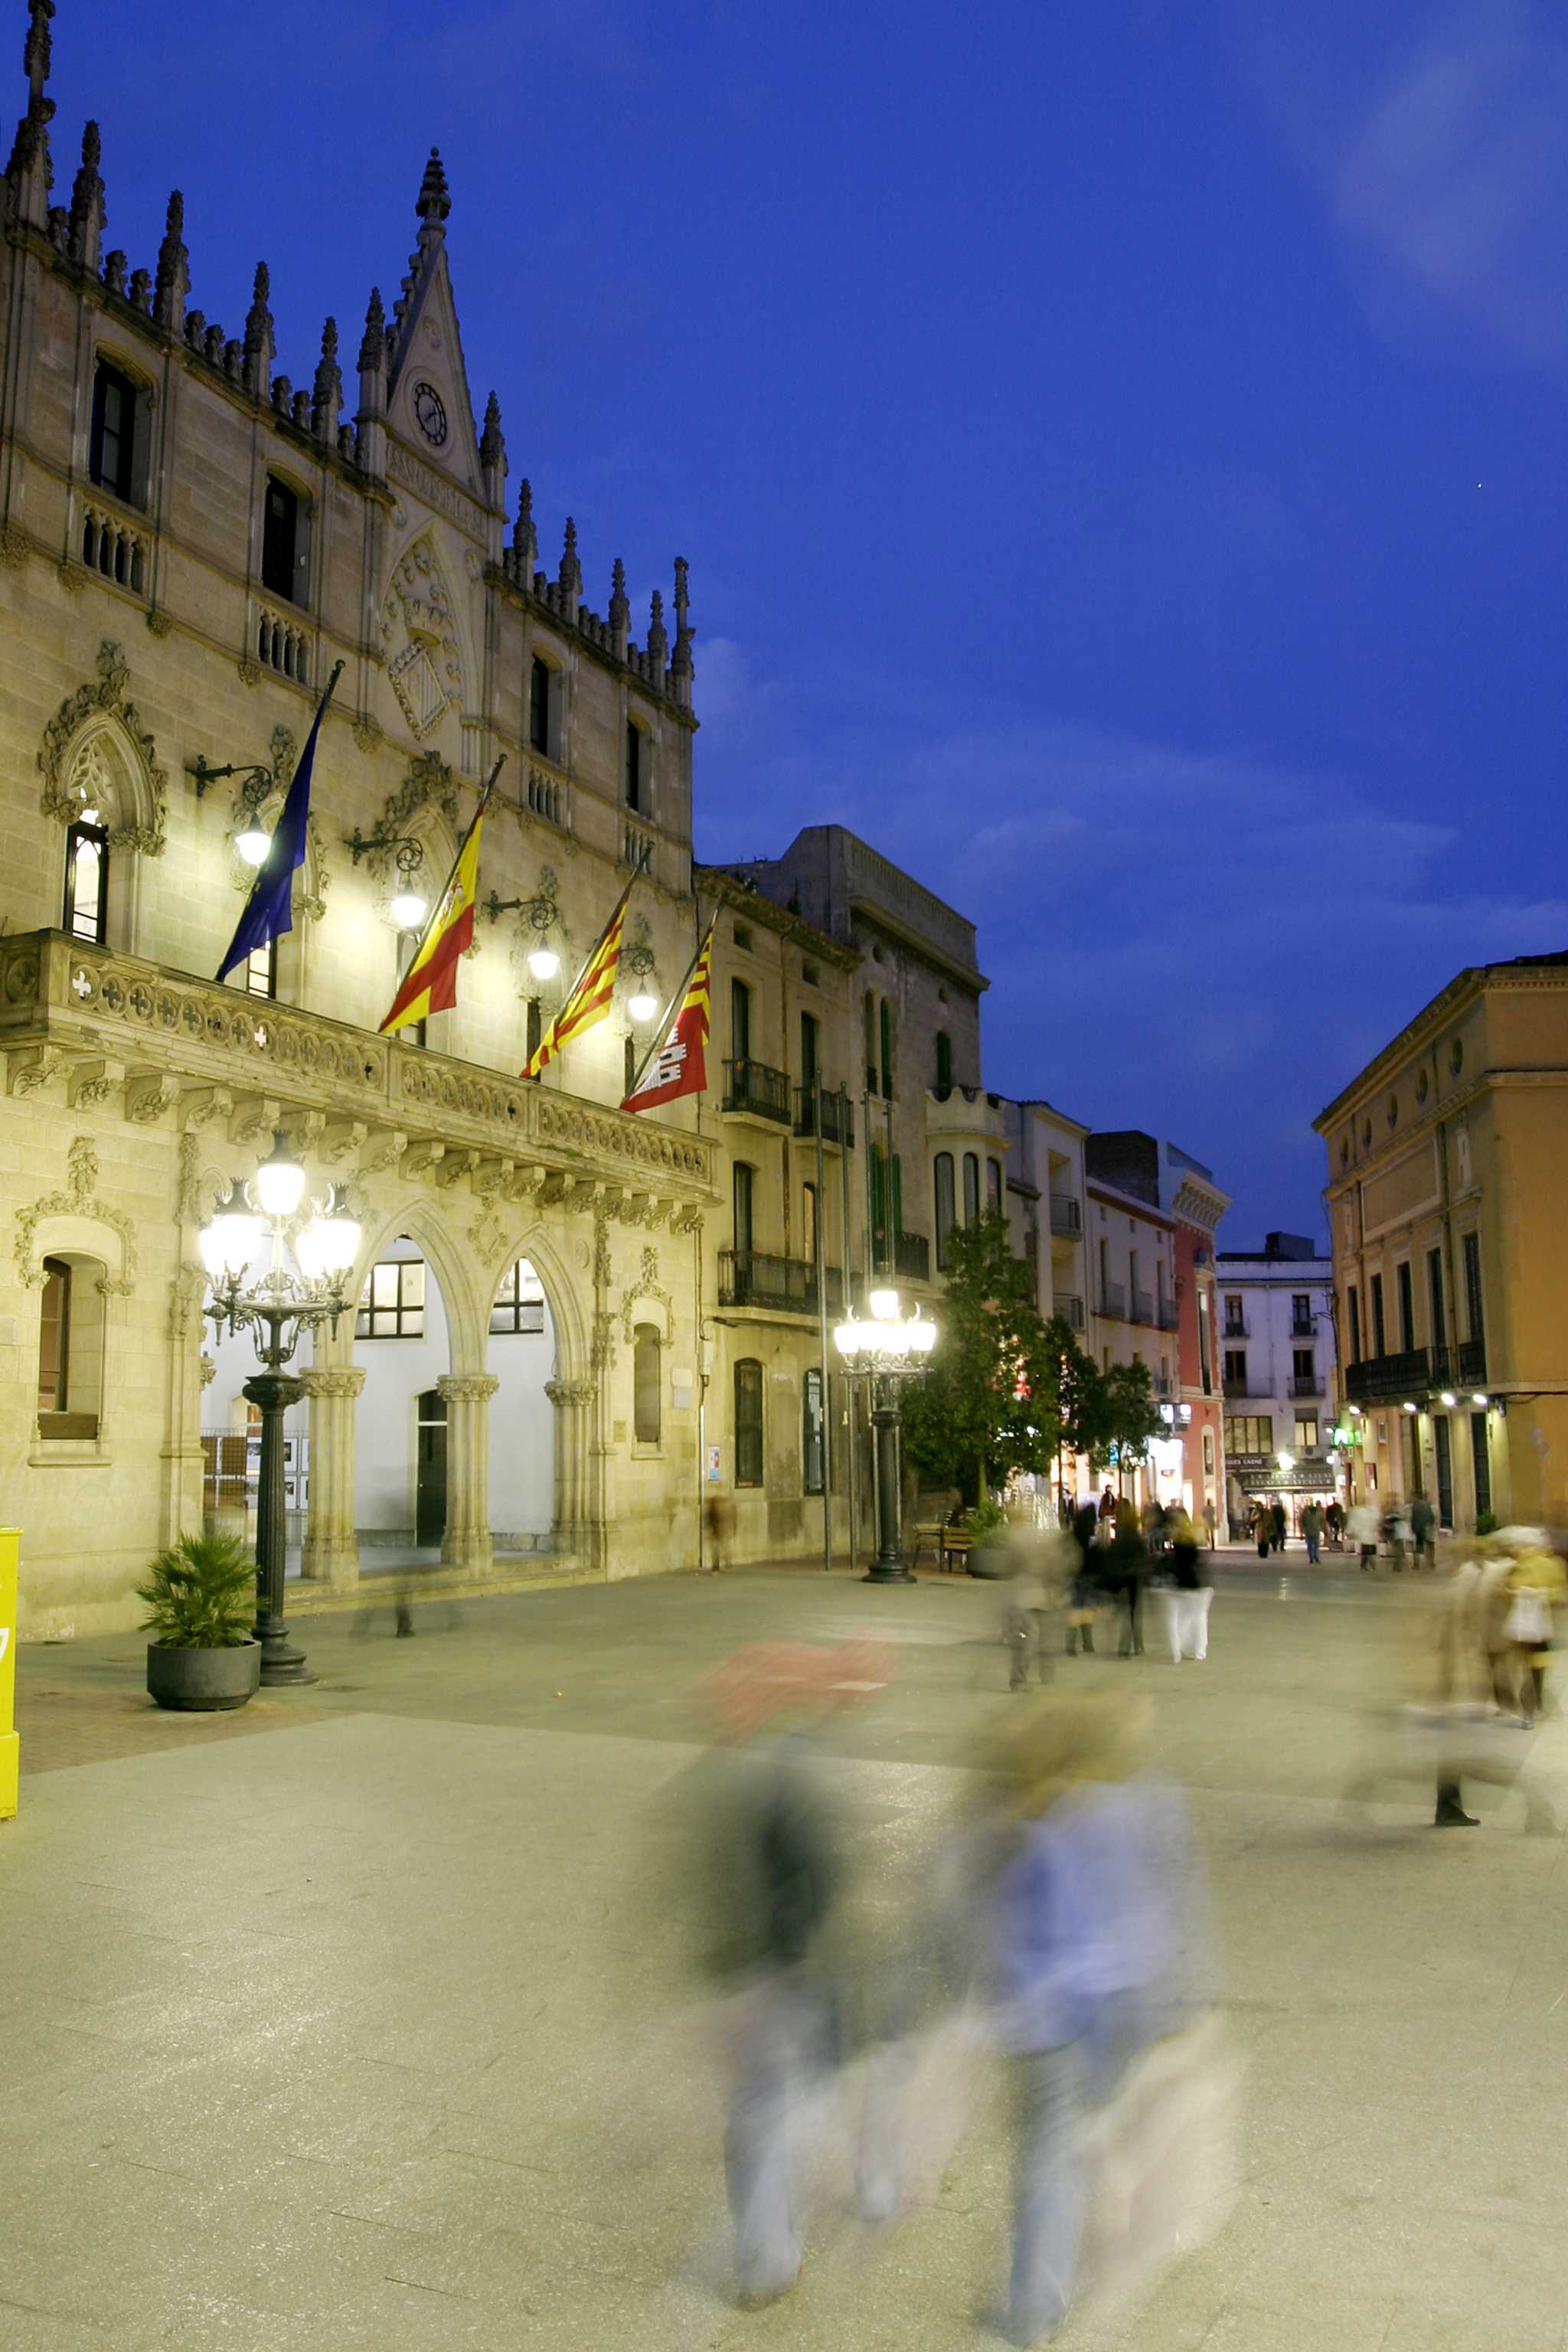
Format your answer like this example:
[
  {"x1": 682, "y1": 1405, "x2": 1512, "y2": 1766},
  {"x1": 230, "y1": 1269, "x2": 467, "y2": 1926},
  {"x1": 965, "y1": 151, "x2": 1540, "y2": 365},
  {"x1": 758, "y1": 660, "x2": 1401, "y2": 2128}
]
[{"x1": 36, "y1": 0, "x2": 1568, "y2": 1246}]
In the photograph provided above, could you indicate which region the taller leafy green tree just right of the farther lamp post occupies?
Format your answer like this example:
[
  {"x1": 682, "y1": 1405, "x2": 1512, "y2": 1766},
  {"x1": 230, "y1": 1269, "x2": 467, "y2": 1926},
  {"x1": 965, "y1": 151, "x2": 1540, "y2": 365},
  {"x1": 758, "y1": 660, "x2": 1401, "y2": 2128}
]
[{"x1": 903, "y1": 1209, "x2": 1072, "y2": 1501}]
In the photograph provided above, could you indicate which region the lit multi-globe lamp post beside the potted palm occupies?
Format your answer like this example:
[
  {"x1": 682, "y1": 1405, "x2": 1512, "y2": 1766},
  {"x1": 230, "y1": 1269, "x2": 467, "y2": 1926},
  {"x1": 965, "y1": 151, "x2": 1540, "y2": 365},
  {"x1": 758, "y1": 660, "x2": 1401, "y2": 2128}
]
[{"x1": 200, "y1": 1129, "x2": 360, "y2": 1684}]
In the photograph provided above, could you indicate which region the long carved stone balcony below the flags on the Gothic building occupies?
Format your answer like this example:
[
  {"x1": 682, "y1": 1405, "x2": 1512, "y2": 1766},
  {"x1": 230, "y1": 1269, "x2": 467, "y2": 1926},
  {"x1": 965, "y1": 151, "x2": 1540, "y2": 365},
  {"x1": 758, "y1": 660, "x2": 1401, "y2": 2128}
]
[{"x1": 0, "y1": 932, "x2": 712, "y2": 1216}]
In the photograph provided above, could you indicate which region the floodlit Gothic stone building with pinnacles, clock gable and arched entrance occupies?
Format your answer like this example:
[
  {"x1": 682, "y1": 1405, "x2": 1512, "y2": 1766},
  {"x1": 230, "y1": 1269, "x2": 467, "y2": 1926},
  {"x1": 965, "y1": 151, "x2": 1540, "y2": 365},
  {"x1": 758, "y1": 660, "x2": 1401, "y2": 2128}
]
[{"x1": 0, "y1": 22, "x2": 729, "y2": 1635}]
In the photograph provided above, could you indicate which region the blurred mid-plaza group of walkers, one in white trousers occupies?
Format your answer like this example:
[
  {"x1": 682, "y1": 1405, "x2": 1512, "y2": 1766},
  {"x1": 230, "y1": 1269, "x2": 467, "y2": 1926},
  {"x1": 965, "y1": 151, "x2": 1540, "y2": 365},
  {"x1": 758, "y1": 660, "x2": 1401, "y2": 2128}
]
[{"x1": 988, "y1": 1489, "x2": 1213, "y2": 1691}]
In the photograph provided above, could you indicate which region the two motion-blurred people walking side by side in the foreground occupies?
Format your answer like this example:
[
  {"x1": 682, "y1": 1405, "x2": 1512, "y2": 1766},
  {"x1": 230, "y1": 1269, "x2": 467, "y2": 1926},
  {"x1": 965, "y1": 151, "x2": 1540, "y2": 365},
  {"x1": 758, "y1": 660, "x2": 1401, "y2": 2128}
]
[{"x1": 694, "y1": 1644, "x2": 1236, "y2": 2345}]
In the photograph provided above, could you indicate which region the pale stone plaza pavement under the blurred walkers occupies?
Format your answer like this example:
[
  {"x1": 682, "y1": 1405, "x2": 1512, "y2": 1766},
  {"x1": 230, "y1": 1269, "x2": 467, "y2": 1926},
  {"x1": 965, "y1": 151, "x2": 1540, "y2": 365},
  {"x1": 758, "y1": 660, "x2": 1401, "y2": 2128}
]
[{"x1": 0, "y1": 1555, "x2": 1568, "y2": 2352}]
